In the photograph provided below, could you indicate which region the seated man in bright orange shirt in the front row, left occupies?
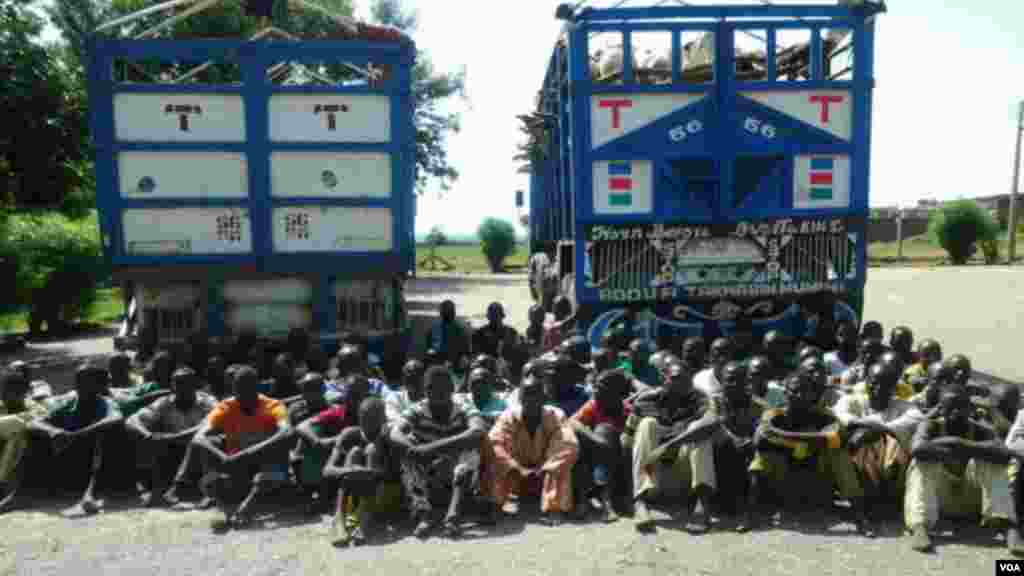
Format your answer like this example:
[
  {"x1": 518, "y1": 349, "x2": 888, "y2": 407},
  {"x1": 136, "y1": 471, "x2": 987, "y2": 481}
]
[{"x1": 193, "y1": 366, "x2": 293, "y2": 529}]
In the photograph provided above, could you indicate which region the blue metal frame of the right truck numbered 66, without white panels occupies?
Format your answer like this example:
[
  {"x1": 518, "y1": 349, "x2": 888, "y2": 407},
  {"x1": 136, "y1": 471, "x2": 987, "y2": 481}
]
[{"x1": 530, "y1": 4, "x2": 885, "y2": 340}]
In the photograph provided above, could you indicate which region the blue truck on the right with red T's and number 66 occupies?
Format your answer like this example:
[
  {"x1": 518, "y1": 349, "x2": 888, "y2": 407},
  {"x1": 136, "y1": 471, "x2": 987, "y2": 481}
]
[{"x1": 520, "y1": 0, "x2": 886, "y2": 345}]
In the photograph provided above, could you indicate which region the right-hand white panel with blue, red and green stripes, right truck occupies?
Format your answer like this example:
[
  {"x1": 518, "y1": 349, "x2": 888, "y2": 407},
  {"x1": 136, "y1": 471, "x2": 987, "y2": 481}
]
[{"x1": 793, "y1": 155, "x2": 850, "y2": 210}]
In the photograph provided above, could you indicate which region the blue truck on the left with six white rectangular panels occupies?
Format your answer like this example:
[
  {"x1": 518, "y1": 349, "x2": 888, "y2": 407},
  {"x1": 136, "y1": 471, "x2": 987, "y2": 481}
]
[{"x1": 88, "y1": 0, "x2": 416, "y2": 357}]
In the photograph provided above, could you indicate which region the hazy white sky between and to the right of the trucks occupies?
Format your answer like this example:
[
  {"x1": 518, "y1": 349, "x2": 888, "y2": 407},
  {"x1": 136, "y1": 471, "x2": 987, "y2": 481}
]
[{"x1": 36, "y1": 0, "x2": 1024, "y2": 234}]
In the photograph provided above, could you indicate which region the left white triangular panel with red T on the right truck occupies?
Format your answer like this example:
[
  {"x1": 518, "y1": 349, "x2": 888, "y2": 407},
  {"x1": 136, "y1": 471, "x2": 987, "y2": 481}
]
[{"x1": 590, "y1": 94, "x2": 705, "y2": 148}]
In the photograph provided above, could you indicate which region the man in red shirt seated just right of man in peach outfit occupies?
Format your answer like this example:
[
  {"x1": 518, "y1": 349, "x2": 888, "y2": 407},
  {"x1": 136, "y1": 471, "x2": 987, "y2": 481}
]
[{"x1": 569, "y1": 370, "x2": 630, "y2": 522}]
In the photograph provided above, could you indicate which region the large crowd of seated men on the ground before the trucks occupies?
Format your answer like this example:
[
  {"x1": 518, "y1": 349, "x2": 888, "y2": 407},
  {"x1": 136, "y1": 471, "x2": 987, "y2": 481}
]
[{"x1": 0, "y1": 311, "x2": 1024, "y2": 552}]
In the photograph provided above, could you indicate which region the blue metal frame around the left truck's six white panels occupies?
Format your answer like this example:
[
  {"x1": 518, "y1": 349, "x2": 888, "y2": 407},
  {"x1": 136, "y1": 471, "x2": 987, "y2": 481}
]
[{"x1": 88, "y1": 38, "x2": 416, "y2": 277}]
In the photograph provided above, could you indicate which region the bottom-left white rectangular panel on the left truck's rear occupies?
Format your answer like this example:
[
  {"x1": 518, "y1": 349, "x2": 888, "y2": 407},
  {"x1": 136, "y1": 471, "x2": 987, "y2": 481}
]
[{"x1": 122, "y1": 204, "x2": 253, "y2": 255}]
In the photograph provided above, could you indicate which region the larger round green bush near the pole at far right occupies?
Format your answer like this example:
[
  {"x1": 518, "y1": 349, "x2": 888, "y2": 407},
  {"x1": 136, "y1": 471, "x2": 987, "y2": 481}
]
[{"x1": 928, "y1": 200, "x2": 999, "y2": 265}]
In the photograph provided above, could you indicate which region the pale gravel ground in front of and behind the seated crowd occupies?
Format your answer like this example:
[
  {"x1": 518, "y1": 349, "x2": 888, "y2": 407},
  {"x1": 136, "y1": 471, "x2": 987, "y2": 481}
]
[{"x1": 0, "y1": 268, "x2": 1024, "y2": 576}]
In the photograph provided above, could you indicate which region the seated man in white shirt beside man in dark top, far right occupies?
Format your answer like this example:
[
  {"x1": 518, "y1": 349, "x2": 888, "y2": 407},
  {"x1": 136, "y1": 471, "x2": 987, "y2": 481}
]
[{"x1": 834, "y1": 364, "x2": 925, "y2": 500}]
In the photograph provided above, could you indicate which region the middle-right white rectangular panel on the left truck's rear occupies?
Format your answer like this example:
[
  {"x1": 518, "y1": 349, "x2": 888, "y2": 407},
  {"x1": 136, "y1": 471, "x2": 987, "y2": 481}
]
[{"x1": 270, "y1": 152, "x2": 391, "y2": 198}]
